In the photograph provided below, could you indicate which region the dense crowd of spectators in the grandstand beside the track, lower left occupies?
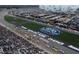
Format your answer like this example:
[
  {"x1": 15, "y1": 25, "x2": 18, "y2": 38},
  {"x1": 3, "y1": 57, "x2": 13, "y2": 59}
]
[{"x1": 0, "y1": 26, "x2": 47, "y2": 54}]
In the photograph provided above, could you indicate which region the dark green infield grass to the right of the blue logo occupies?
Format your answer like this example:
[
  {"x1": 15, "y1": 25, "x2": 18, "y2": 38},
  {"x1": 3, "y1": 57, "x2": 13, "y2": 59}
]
[{"x1": 56, "y1": 32, "x2": 79, "y2": 47}]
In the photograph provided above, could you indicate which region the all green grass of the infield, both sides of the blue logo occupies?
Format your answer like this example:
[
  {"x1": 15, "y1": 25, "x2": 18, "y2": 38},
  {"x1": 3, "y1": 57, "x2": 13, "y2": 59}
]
[{"x1": 5, "y1": 16, "x2": 79, "y2": 47}]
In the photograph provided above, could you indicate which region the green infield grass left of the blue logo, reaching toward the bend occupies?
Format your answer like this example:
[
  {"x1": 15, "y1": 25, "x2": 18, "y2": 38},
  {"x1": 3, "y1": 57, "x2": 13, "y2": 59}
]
[{"x1": 5, "y1": 16, "x2": 45, "y2": 31}]
